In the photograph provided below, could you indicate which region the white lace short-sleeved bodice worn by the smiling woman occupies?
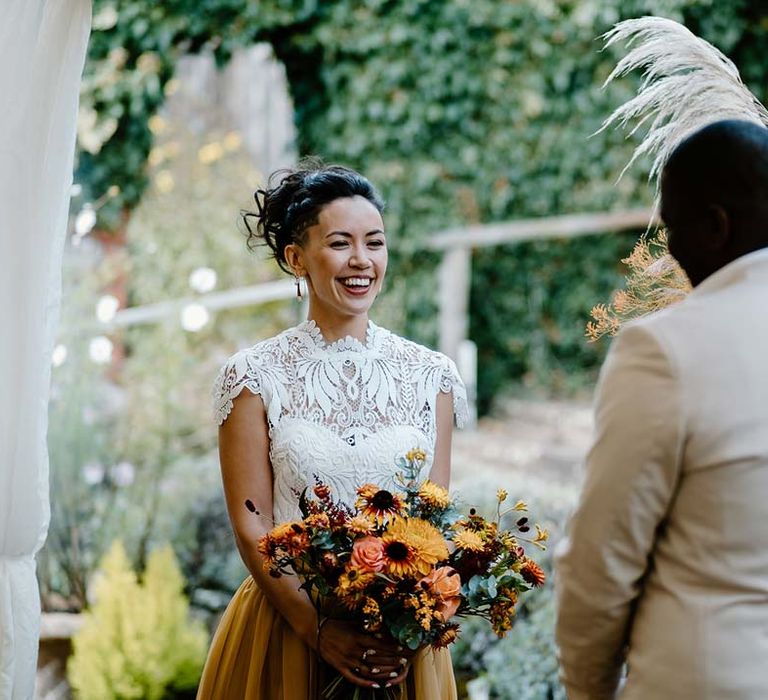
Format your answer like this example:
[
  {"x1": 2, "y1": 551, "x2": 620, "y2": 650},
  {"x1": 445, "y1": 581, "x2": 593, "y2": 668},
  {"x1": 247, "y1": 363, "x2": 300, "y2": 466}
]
[{"x1": 213, "y1": 321, "x2": 467, "y2": 522}]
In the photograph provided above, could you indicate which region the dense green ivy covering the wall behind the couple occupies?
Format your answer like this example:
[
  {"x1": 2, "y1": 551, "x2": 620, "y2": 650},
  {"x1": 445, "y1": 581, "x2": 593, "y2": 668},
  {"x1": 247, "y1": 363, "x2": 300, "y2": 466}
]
[{"x1": 78, "y1": 0, "x2": 768, "y2": 409}]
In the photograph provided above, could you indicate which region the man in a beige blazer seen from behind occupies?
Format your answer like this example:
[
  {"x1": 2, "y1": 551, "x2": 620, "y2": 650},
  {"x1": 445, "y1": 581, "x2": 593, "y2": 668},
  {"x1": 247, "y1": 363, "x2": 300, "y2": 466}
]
[{"x1": 557, "y1": 121, "x2": 768, "y2": 700}]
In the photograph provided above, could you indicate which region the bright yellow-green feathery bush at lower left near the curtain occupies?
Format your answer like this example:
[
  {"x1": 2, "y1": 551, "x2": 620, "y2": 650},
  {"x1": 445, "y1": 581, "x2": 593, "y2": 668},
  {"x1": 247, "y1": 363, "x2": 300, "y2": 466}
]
[{"x1": 67, "y1": 541, "x2": 208, "y2": 700}]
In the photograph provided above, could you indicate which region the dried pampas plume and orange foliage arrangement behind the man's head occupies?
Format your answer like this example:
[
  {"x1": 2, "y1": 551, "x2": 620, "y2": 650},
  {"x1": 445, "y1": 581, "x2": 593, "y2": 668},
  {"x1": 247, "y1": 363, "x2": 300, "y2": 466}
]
[{"x1": 586, "y1": 17, "x2": 768, "y2": 341}]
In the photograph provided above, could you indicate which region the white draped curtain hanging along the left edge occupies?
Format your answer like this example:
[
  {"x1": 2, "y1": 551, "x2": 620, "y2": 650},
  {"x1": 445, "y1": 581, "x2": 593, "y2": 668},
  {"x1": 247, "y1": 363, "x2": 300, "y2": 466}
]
[{"x1": 0, "y1": 0, "x2": 91, "y2": 700}]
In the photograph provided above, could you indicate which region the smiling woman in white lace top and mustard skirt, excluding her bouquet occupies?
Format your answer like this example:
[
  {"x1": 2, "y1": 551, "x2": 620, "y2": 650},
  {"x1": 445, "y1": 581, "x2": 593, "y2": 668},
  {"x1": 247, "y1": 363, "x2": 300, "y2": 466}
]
[{"x1": 198, "y1": 163, "x2": 466, "y2": 700}]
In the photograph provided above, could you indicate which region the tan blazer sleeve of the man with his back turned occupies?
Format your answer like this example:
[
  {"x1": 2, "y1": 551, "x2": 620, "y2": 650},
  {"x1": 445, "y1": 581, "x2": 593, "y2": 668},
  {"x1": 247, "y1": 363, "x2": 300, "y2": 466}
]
[{"x1": 556, "y1": 325, "x2": 683, "y2": 700}]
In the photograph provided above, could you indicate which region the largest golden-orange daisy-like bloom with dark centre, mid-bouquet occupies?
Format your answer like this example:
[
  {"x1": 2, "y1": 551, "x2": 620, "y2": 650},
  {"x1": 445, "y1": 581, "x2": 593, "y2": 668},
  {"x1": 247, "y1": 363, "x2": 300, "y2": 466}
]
[{"x1": 382, "y1": 518, "x2": 448, "y2": 576}]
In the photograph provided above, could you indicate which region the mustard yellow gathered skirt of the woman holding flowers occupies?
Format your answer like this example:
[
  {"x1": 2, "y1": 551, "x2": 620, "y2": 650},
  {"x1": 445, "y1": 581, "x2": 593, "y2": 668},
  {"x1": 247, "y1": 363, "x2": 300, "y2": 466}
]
[{"x1": 197, "y1": 576, "x2": 457, "y2": 700}]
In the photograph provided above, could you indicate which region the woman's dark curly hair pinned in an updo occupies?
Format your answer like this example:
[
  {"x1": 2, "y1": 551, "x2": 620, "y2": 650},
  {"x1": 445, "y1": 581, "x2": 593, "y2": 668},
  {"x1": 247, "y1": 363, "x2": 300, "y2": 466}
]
[{"x1": 242, "y1": 159, "x2": 384, "y2": 274}]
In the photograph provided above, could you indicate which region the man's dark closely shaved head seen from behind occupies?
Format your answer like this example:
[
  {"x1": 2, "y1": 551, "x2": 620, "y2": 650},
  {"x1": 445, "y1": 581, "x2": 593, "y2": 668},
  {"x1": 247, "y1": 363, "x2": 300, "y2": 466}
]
[{"x1": 661, "y1": 120, "x2": 768, "y2": 285}]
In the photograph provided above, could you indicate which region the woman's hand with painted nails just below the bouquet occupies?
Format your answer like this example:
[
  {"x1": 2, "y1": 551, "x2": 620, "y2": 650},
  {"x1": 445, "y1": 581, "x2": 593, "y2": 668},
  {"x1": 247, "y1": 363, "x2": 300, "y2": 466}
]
[{"x1": 318, "y1": 620, "x2": 416, "y2": 688}]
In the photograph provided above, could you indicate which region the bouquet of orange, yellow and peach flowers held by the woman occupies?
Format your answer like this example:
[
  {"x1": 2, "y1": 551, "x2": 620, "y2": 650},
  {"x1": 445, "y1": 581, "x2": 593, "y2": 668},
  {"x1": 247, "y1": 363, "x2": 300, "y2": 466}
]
[{"x1": 259, "y1": 450, "x2": 547, "y2": 698}]
